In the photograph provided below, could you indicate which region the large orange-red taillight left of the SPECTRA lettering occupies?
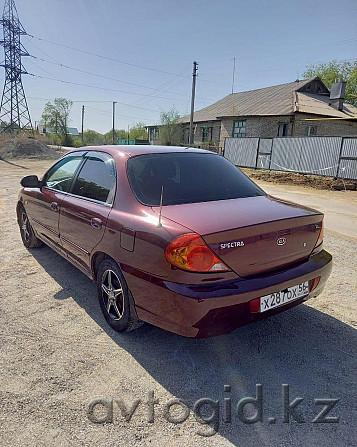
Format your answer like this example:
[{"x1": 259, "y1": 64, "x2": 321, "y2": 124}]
[{"x1": 165, "y1": 233, "x2": 230, "y2": 272}]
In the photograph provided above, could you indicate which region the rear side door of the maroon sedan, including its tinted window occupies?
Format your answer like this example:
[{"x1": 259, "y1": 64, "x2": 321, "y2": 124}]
[{"x1": 59, "y1": 151, "x2": 116, "y2": 272}]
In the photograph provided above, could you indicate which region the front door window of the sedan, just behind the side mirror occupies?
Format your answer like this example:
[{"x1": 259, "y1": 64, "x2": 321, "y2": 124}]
[{"x1": 44, "y1": 156, "x2": 83, "y2": 192}]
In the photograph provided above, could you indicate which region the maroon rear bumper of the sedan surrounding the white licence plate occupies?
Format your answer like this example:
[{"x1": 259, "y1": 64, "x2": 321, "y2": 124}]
[{"x1": 122, "y1": 250, "x2": 332, "y2": 337}]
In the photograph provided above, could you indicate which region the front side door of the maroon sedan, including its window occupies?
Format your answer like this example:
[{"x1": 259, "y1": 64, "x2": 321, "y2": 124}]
[{"x1": 28, "y1": 152, "x2": 84, "y2": 248}]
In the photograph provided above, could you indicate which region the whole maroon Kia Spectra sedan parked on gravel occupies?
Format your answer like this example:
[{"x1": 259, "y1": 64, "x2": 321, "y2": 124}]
[{"x1": 17, "y1": 146, "x2": 332, "y2": 337}]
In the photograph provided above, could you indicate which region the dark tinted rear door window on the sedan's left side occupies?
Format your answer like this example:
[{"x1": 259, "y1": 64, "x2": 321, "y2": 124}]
[{"x1": 71, "y1": 155, "x2": 116, "y2": 204}]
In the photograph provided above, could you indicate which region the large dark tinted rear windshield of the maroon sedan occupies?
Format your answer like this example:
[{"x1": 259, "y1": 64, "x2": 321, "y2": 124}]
[{"x1": 127, "y1": 153, "x2": 265, "y2": 206}]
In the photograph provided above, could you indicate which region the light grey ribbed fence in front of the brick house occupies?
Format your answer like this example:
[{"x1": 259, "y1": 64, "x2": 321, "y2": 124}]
[{"x1": 223, "y1": 137, "x2": 357, "y2": 180}]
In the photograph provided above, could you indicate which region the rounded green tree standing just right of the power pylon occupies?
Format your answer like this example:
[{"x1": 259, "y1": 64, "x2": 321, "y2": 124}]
[{"x1": 41, "y1": 98, "x2": 73, "y2": 143}]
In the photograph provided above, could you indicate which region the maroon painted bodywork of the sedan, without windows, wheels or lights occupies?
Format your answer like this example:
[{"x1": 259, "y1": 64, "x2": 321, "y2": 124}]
[{"x1": 19, "y1": 146, "x2": 331, "y2": 337}]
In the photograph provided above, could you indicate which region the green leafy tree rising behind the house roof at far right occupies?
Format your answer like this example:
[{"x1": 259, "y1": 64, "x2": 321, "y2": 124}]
[{"x1": 303, "y1": 60, "x2": 357, "y2": 106}]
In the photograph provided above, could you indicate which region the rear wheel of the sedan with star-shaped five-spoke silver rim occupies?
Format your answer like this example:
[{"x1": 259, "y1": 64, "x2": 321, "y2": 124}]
[{"x1": 97, "y1": 258, "x2": 144, "y2": 332}]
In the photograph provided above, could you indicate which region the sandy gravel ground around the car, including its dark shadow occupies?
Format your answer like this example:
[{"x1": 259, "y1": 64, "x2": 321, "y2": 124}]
[{"x1": 0, "y1": 160, "x2": 357, "y2": 447}]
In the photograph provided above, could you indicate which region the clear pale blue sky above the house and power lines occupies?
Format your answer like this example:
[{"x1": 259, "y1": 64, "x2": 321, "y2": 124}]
[{"x1": 4, "y1": 0, "x2": 357, "y2": 132}]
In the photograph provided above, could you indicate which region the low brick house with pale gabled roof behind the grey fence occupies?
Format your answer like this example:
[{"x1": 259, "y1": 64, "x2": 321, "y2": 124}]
[{"x1": 148, "y1": 77, "x2": 357, "y2": 148}]
